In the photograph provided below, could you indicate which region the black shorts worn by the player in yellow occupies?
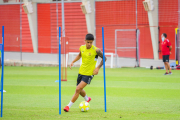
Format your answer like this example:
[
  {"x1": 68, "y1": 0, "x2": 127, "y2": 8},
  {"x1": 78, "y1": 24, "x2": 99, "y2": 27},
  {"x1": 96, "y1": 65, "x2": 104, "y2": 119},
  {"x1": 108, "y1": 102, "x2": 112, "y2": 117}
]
[{"x1": 77, "y1": 74, "x2": 94, "y2": 85}]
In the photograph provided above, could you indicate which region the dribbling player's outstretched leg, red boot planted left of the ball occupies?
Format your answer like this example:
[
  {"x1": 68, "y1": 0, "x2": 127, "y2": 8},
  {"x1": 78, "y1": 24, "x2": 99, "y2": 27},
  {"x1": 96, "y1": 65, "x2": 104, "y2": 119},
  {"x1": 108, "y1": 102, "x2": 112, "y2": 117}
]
[{"x1": 64, "y1": 81, "x2": 87, "y2": 112}]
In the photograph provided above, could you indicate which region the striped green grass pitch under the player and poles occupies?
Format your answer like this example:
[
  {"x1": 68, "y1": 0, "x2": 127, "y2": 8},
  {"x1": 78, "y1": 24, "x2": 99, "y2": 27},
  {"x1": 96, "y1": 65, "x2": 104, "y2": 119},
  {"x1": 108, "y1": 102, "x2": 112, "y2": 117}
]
[{"x1": 1, "y1": 67, "x2": 180, "y2": 120}]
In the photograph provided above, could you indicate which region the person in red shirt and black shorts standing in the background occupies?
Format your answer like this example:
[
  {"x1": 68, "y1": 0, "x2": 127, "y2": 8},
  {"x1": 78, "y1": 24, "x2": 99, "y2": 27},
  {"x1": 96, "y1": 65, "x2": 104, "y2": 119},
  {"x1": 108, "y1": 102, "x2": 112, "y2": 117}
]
[{"x1": 161, "y1": 33, "x2": 172, "y2": 75}]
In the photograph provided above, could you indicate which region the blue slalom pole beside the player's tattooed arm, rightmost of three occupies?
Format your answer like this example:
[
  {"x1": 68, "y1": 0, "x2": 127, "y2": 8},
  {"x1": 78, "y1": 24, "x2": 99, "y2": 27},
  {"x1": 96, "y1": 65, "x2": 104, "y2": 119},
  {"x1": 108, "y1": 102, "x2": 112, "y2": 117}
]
[{"x1": 102, "y1": 27, "x2": 107, "y2": 112}]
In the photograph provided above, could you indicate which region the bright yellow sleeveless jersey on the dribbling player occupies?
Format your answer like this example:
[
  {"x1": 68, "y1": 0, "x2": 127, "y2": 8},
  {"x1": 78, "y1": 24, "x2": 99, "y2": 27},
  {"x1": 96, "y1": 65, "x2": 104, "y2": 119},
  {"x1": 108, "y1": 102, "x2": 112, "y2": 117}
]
[{"x1": 79, "y1": 45, "x2": 98, "y2": 76}]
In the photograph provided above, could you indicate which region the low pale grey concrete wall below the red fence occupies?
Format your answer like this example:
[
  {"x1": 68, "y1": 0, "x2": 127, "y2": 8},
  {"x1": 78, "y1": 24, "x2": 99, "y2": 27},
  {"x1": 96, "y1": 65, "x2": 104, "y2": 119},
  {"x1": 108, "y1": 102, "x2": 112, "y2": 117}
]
[{"x1": 4, "y1": 52, "x2": 175, "y2": 68}]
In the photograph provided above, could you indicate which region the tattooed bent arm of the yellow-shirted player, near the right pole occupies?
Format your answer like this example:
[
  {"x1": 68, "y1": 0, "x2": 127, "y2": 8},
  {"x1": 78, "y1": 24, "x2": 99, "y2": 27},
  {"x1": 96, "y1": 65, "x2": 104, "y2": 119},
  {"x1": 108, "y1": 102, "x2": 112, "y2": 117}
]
[{"x1": 93, "y1": 49, "x2": 107, "y2": 75}]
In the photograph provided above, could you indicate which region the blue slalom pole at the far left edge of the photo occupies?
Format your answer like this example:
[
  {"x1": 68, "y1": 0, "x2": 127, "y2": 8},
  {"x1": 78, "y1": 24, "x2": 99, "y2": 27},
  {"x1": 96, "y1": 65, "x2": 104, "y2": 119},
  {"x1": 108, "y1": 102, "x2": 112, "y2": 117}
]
[{"x1": 1, "y1": 26, "x2": 4, "y2": 117}]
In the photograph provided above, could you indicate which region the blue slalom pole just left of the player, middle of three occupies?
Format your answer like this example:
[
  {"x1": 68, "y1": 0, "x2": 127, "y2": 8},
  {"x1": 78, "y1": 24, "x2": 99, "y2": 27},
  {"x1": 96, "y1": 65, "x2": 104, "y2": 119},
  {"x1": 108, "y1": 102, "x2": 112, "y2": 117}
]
[{"x1": 59, "y1": 27, "x2": 61, "y2": 115}]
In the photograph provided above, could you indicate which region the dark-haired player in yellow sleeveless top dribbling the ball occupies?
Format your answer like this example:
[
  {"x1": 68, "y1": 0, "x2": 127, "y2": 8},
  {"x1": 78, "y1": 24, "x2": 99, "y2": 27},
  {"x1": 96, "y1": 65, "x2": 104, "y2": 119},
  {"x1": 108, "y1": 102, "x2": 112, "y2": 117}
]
[{"x1": 64, "y1": 34, "x2": 107, "y2": 112}]
